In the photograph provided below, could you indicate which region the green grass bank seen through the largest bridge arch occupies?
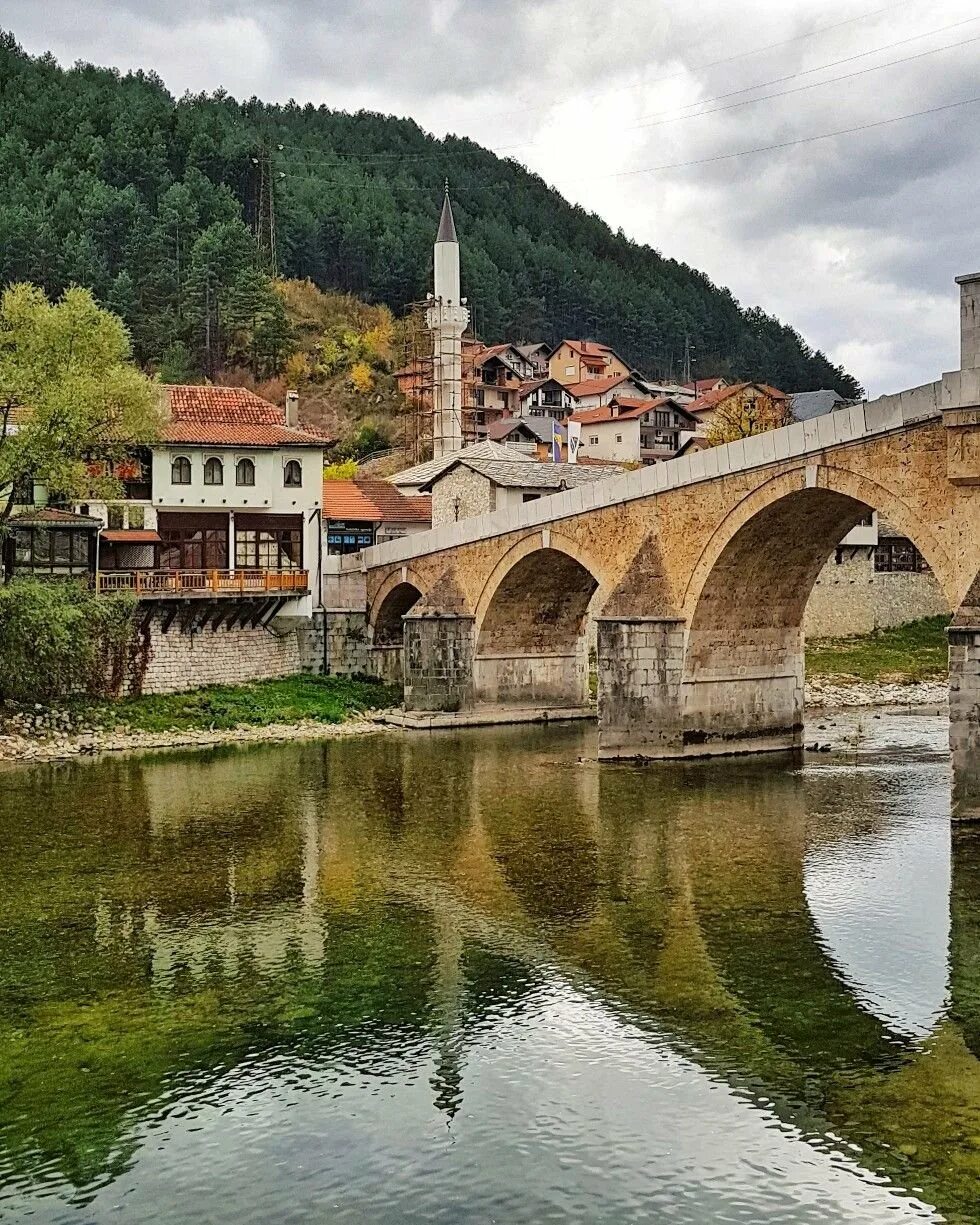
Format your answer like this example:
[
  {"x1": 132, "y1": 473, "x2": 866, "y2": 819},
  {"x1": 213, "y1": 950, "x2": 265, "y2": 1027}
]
[{"x1": 806, "y1": 616, "x2": 949, "y2": 685}]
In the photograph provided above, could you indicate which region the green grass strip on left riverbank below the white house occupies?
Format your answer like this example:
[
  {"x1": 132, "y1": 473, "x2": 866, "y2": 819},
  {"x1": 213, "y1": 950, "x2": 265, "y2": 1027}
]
[{"x1": 70, "y1": 676, "x2": 401, "y2": 731}]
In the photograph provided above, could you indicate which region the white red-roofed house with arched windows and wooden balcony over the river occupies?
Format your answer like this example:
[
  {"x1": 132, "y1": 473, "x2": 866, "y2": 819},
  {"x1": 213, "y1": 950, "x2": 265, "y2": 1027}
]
[{"x1": 70, "y1": 386, "x2": 330, "y2": 616}]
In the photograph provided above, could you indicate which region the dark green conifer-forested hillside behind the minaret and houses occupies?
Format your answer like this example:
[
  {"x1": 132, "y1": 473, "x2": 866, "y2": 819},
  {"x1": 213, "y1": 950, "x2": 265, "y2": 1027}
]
[{"x1": 0, "y1": 34, "x2": 860, "y2": 394}]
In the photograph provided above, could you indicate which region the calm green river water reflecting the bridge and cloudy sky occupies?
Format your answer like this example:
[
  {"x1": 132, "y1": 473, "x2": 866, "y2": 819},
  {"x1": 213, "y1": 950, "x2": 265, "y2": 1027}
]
[{"x1": 0, "y1": 717, "x2": 980, "y2": 1225}]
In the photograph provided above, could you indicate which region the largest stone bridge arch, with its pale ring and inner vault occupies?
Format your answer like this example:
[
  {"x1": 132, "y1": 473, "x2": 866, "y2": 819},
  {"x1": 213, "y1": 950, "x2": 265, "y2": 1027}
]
[{"x1": 680, "y1": 466, "x2": 962, "y2": 752}]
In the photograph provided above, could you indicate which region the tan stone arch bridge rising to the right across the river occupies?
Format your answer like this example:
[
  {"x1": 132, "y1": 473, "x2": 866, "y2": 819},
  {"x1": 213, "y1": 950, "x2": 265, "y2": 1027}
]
[{"x1": 325, "y1": 392, "x2": 980, "y2": 808}]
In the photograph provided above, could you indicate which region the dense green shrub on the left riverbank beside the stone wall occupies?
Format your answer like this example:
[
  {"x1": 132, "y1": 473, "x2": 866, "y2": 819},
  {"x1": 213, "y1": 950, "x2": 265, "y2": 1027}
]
[{"x1": 0, "y1": 578, "x2": 136, "y2": 702}]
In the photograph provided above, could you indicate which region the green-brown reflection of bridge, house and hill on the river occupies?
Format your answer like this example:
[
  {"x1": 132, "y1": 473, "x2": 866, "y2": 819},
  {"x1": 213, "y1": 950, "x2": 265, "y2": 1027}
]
[{"x1": 0, "y1": 729, "x2": 980, "y2": 1220}]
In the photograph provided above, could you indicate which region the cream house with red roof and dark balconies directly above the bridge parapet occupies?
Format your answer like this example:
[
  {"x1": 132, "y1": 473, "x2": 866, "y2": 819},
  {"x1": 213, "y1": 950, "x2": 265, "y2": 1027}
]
[{"x1": 570, "y1": 396, "x2": 697, "y2": 464}]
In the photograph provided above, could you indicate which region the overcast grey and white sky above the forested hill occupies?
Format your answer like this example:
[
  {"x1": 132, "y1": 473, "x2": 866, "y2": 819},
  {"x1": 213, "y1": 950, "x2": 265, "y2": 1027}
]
[{"x1": 7, "y1": 0, "x2": 980, "y2": 394}]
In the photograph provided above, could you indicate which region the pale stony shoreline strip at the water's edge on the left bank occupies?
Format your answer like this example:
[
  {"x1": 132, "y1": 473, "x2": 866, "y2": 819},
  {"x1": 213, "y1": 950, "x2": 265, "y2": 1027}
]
[{"x1": 0, "y1": 713, "x2": 381, "y2": 761}]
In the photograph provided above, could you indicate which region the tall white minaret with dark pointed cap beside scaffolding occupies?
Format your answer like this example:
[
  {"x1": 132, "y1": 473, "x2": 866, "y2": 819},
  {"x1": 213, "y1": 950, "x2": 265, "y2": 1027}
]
[{"x1": 425, "y1": 180, "x2": 469, "y2": 459}]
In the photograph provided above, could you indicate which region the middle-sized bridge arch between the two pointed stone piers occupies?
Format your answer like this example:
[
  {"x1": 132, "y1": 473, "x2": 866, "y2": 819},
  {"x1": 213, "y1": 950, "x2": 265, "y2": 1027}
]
[{"x1": 473, "y1": 532, "x2": 599, "y2": 709}]
